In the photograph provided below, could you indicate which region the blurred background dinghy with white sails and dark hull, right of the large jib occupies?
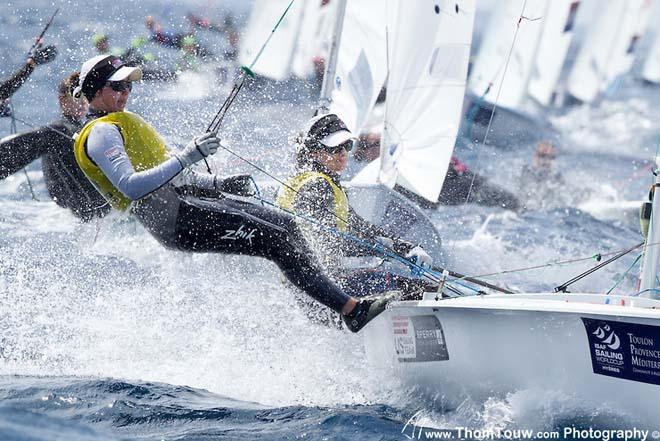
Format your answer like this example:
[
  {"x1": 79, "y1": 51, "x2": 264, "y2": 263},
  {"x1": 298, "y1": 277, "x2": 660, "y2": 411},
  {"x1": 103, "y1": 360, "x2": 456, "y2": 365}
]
[{"x1": 462, "y1": 0, "x2": 580, "y2": 144}]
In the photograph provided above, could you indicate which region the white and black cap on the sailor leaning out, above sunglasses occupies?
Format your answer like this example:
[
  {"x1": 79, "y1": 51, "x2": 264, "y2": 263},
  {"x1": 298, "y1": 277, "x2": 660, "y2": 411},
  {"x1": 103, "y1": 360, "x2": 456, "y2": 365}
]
[{"x1": 73, "y1": 55, "x2": 142, "y2": 98}]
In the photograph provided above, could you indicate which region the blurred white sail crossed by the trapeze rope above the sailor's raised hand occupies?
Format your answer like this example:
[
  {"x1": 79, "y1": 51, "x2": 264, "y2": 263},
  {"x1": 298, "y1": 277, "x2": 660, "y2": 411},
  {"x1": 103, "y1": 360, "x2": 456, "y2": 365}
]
[{"x1": 239, "y1": 0, "x2": 311, "y2": 81}]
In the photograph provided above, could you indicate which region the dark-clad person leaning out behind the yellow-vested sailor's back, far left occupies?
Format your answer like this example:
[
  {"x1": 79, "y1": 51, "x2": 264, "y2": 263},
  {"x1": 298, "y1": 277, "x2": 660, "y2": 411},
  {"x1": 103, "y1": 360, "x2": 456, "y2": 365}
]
[{"x1": 0, "y1": 72, "x2": 110, "y2": 221}]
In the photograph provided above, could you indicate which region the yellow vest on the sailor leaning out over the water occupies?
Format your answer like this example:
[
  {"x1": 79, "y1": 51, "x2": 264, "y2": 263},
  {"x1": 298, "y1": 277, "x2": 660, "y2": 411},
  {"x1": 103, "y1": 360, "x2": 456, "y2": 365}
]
[{"x1": 73, "y1": 112, "x2": 170, "y2": 211}]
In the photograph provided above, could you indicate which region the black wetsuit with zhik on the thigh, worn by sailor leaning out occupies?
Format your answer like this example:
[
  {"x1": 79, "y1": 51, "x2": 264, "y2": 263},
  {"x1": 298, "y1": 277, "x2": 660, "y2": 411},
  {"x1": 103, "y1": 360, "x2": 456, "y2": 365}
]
[{"x1": 85, "y1": 109, "x2": 350, "y2": 312}]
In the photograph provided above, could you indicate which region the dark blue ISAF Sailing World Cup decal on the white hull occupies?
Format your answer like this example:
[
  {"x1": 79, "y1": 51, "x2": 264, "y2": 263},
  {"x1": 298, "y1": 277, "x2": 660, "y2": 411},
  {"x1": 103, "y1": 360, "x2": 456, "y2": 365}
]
[{"x1": 582, "y1": 317, "x2": 660, "y2": 384}]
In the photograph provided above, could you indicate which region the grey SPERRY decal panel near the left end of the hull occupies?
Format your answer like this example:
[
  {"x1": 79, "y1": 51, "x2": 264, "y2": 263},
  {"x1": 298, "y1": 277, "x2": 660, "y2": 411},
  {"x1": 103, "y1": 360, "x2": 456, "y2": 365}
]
[{"x1": 392, "y1": 315, "x2": 449, "y2": 363}]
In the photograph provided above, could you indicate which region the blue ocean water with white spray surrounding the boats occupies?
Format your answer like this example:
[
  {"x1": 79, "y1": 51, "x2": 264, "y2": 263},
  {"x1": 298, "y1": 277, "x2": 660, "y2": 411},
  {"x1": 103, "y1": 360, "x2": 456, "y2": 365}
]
[{"x1": 0, "y1": 0, "x2": 660, "y2": 440}]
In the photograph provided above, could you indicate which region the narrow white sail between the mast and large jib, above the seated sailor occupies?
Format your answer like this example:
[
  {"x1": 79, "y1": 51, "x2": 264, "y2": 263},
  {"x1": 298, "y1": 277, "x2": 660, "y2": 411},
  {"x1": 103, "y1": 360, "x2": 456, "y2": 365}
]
[{"x1": 330, "y1": 0, "x2": 387, "y2": 134}]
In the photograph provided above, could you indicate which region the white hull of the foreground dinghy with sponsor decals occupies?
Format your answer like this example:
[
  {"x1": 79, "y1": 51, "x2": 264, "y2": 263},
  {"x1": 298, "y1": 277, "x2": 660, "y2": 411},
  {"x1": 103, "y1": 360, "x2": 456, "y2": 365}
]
[{"x1": 364, "y1": 294, "x2": 660, "y2": 422}]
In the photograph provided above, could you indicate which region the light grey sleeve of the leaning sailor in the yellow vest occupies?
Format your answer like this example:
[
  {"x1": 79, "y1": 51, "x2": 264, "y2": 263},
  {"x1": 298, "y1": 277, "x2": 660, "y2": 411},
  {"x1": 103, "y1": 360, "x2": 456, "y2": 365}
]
[{"x1": 87, "y1": 123, "x2": 182, "y2": 201}]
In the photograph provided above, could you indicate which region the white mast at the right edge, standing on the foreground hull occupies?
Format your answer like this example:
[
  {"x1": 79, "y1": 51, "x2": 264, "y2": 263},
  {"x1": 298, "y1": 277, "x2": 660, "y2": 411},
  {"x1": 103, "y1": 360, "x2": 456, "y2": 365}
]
[{"x1": 639, "y1": 156, "x2": 660, "y2": 300}]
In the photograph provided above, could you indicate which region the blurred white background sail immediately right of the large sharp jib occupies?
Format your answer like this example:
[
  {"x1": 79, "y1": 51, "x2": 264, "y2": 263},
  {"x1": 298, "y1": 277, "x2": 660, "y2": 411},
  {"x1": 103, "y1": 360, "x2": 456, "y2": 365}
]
[{"x1": 470, "y1": 0, "x2": 549, "y2": 109}]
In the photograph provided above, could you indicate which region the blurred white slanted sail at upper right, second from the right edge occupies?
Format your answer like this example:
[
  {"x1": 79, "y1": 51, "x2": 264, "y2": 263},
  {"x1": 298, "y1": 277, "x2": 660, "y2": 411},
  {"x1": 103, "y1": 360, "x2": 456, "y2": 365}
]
[{"x1": 566, "y1": 0, "x2": 650, "y2": 103}]
